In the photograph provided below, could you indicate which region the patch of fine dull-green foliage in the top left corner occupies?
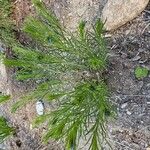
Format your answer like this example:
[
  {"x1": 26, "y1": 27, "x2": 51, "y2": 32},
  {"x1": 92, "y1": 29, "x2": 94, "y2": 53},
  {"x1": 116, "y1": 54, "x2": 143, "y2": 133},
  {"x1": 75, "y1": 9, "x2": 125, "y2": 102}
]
[{"x1": 0, "y1": 0, "x2": 15, "y2": 46}]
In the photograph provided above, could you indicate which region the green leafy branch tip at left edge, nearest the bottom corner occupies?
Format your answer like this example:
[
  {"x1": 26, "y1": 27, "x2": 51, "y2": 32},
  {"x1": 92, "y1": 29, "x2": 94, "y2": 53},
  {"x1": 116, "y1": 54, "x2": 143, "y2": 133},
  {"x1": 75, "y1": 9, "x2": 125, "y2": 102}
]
[{"x1": 0, "y1": 117, "x2": 15, "y2": 143}]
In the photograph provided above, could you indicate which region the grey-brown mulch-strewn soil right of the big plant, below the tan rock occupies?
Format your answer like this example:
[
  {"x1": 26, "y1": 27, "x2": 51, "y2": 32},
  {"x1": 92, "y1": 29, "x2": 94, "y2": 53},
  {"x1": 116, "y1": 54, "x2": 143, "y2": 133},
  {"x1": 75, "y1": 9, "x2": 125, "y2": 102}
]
[{"x1": 108, "y1": 7, "x2": 150, "y2": 150}]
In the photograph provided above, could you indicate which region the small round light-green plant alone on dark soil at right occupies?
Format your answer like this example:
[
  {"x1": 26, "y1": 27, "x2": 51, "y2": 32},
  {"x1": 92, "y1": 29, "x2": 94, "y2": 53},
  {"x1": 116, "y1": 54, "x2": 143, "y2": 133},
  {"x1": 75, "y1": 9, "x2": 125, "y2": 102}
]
[{"x1": 135, "y1": 67, "x2": 149, "y2": 79}]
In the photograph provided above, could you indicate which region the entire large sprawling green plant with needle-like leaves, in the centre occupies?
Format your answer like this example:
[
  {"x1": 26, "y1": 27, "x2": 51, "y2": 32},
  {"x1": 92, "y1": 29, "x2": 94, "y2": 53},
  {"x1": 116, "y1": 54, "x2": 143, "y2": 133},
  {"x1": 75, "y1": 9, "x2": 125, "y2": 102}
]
[{"x1": 4, "y1": 0, "x2": 115, "y2": 150}]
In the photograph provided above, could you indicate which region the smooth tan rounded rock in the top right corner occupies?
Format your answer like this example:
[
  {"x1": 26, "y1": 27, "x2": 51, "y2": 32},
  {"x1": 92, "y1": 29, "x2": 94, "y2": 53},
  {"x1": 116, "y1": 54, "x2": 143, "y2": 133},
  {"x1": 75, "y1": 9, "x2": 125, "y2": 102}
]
[{"x1": 102, "y1": 0, "x2": 149, "y2": 30}]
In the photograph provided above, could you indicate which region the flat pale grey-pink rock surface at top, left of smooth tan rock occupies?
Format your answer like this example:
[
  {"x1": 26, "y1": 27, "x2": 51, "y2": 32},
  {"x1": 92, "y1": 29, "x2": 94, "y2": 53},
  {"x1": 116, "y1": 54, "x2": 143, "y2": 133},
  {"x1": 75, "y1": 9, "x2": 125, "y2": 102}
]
[{"x1": 47, "y1": 0, "x2": 107, "y2": 32}]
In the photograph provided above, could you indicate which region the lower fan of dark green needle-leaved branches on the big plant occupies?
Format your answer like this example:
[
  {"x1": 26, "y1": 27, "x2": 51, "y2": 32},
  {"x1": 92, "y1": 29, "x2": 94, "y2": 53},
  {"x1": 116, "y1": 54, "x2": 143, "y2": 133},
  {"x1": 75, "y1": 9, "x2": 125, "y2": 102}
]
[{"x1": 40, "y1": 81, "x2": 113, "y2": 150}]
